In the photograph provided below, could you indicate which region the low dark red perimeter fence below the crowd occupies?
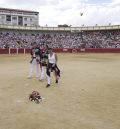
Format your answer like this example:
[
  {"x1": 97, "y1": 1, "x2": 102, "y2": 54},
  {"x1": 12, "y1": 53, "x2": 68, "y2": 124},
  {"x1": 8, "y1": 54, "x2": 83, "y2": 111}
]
[{"x1": 0, "y1": 48, "x2": 120, "y2": 54}]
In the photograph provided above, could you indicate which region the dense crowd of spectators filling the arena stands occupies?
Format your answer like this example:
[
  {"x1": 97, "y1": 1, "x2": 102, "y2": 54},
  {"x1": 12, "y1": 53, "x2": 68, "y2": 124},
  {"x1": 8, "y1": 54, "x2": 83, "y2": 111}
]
[{"x1": 0, "y1": 30, "x2": 120, "y2": 48}]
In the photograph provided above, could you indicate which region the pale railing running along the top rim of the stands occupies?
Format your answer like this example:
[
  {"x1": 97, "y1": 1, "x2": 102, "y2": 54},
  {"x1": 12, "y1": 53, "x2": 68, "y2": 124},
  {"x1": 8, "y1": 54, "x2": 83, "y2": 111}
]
[{"x1": 0, "y1": 24, "x2": 120, "y2": 32}]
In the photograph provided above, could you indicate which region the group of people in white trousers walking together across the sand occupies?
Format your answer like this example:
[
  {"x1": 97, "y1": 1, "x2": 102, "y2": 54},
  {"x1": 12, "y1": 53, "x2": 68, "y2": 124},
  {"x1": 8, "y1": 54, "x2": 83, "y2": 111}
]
[{"x1": 28, "y1": 42, "x2": 60, "y2": 87}]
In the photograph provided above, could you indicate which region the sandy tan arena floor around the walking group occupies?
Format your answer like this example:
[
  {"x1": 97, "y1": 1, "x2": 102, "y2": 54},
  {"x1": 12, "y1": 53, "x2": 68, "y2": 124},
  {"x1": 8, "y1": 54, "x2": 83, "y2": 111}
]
[{"x1": 0, "y1": 54, "x2": 120, "y2": 129}]
